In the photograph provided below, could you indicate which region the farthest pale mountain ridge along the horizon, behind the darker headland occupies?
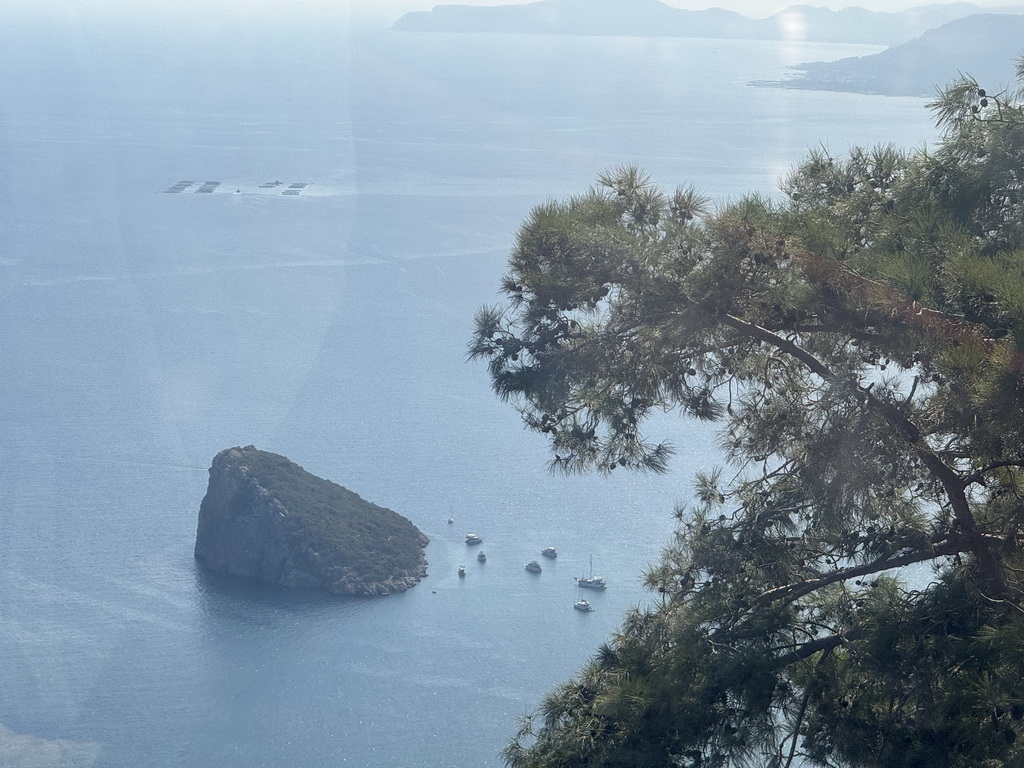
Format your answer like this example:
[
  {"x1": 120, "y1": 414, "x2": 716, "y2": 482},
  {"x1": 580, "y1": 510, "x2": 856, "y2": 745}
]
[{"x1": 392, "y1": 0, "x2": 1024, "y2": 45}]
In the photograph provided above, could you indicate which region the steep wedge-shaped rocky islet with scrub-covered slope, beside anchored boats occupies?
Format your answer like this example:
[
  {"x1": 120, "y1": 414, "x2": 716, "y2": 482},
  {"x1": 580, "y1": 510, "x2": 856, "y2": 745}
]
[{"x1": 196, "y1": 445, "x2": 429, "y2": 595}]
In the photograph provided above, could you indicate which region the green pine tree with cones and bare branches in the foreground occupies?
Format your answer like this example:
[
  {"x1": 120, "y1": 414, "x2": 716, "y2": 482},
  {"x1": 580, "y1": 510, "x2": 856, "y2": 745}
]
[{"x1": 471, "y1": 60, "x2": 1024, "y2": 768}]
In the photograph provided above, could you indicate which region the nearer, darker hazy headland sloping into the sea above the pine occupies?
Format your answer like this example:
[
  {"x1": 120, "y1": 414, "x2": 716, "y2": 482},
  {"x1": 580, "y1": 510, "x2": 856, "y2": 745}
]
[{"x1": 759, "y1": 13, "x2": 1024, "y2": 96}]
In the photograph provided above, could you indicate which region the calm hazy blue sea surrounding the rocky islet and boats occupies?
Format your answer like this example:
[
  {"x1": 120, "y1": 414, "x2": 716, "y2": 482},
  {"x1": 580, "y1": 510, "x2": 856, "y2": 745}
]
[{"x1": 0, "y1": 5, "x2": 935, "y2": 768}]
